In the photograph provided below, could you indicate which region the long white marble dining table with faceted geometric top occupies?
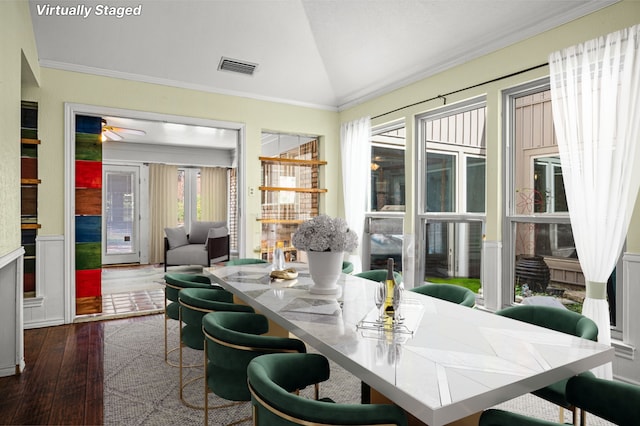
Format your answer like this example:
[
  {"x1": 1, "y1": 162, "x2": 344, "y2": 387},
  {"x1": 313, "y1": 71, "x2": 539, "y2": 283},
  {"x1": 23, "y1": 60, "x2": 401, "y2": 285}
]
[{"x1": 204, "y1": 264, "x2": 614, "y2": 426}]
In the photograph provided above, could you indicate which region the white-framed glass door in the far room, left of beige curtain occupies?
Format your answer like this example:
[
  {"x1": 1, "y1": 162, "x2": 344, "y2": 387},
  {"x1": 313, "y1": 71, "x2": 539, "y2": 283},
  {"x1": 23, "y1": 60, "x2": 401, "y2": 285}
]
[{"x1": 102, "y1": 164, "x2": 140, "y2": 265}]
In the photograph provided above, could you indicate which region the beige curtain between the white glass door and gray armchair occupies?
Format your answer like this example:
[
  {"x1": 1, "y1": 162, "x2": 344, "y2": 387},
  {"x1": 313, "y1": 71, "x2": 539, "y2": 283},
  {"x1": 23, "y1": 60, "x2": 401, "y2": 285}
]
[{"x1": 149, "y1": 163, "x2": 178, "y2": 263}]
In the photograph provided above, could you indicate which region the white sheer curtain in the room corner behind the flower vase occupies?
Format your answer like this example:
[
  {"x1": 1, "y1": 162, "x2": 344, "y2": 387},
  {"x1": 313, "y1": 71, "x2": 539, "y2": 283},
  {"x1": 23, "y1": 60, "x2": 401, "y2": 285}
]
[{"x1": 340, "y1": 117, "x2": 371, "y2": 273}]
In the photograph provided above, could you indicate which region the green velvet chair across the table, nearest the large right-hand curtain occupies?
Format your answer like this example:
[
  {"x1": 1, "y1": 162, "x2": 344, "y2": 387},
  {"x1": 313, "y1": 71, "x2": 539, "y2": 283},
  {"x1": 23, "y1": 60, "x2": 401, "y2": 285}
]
[{"x1": 496, "y1": 305, "x2": 598, "y2": 425}]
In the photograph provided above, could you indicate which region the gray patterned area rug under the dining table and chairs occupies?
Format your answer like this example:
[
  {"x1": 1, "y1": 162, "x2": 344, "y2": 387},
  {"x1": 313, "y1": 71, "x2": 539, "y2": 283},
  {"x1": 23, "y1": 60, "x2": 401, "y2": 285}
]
[{"x1": 104, "y1": 315, "x2": 612, "y2": 426}]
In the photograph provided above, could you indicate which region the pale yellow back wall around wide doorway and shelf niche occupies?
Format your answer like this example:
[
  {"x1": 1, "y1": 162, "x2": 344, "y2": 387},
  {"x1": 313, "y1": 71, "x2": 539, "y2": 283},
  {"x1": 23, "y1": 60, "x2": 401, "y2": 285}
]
[{"x1": 29, "y1": 68, "x2": 341, "y2": 255}]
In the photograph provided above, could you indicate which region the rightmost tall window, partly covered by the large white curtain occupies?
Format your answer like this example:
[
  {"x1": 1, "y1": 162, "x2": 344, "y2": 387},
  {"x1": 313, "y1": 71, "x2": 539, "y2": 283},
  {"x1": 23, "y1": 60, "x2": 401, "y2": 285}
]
[{"x1": 503, "y1": 80, "x2": 620, "y2": 330}]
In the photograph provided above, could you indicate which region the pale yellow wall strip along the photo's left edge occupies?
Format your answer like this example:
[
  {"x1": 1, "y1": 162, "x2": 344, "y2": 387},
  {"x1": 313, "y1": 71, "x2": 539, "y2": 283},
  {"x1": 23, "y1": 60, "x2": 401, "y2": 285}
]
[{"x1": 0, "y1": 1, "x2": 40, "y2": 256}]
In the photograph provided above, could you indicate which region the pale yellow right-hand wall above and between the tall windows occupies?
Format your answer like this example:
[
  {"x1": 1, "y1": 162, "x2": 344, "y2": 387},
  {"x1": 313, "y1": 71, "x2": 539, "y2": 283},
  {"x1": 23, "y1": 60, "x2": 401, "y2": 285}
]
[{"x1": 340, "y1": 0, "x2": 640, "y2": 253}]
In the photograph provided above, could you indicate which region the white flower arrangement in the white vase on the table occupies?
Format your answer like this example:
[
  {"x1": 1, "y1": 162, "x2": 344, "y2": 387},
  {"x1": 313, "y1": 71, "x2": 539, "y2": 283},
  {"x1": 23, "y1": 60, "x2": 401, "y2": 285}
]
[{"x1": 292, "y1": 214, "x2": 358, "y2": 252}]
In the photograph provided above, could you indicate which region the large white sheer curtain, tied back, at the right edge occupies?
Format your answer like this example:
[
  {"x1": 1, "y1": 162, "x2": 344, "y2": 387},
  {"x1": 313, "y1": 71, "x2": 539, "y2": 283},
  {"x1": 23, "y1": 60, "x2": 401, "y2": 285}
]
[{"x1": 549, "y1": 25, "x2": 640, "y2": 378}]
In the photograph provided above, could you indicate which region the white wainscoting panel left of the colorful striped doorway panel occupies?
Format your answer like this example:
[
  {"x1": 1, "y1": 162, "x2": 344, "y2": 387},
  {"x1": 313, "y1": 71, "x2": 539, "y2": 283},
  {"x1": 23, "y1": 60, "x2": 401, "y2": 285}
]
[{"x1": 24, "y1": 235, "x2": 65, "y2": 328}]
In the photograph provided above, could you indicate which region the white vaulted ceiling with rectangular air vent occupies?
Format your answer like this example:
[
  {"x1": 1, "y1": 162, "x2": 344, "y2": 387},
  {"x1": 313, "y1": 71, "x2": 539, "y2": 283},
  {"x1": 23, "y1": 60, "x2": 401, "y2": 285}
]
[{"x1": 30, "y1": 0, "x2": 613, "y2": 110}]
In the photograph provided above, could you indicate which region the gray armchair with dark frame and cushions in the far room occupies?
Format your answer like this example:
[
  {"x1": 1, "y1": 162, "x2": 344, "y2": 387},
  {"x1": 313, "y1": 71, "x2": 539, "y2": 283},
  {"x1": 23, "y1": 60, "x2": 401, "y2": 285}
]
[{"x1": 164, "y1": 221, "x2": 230, "y2": 272}]
